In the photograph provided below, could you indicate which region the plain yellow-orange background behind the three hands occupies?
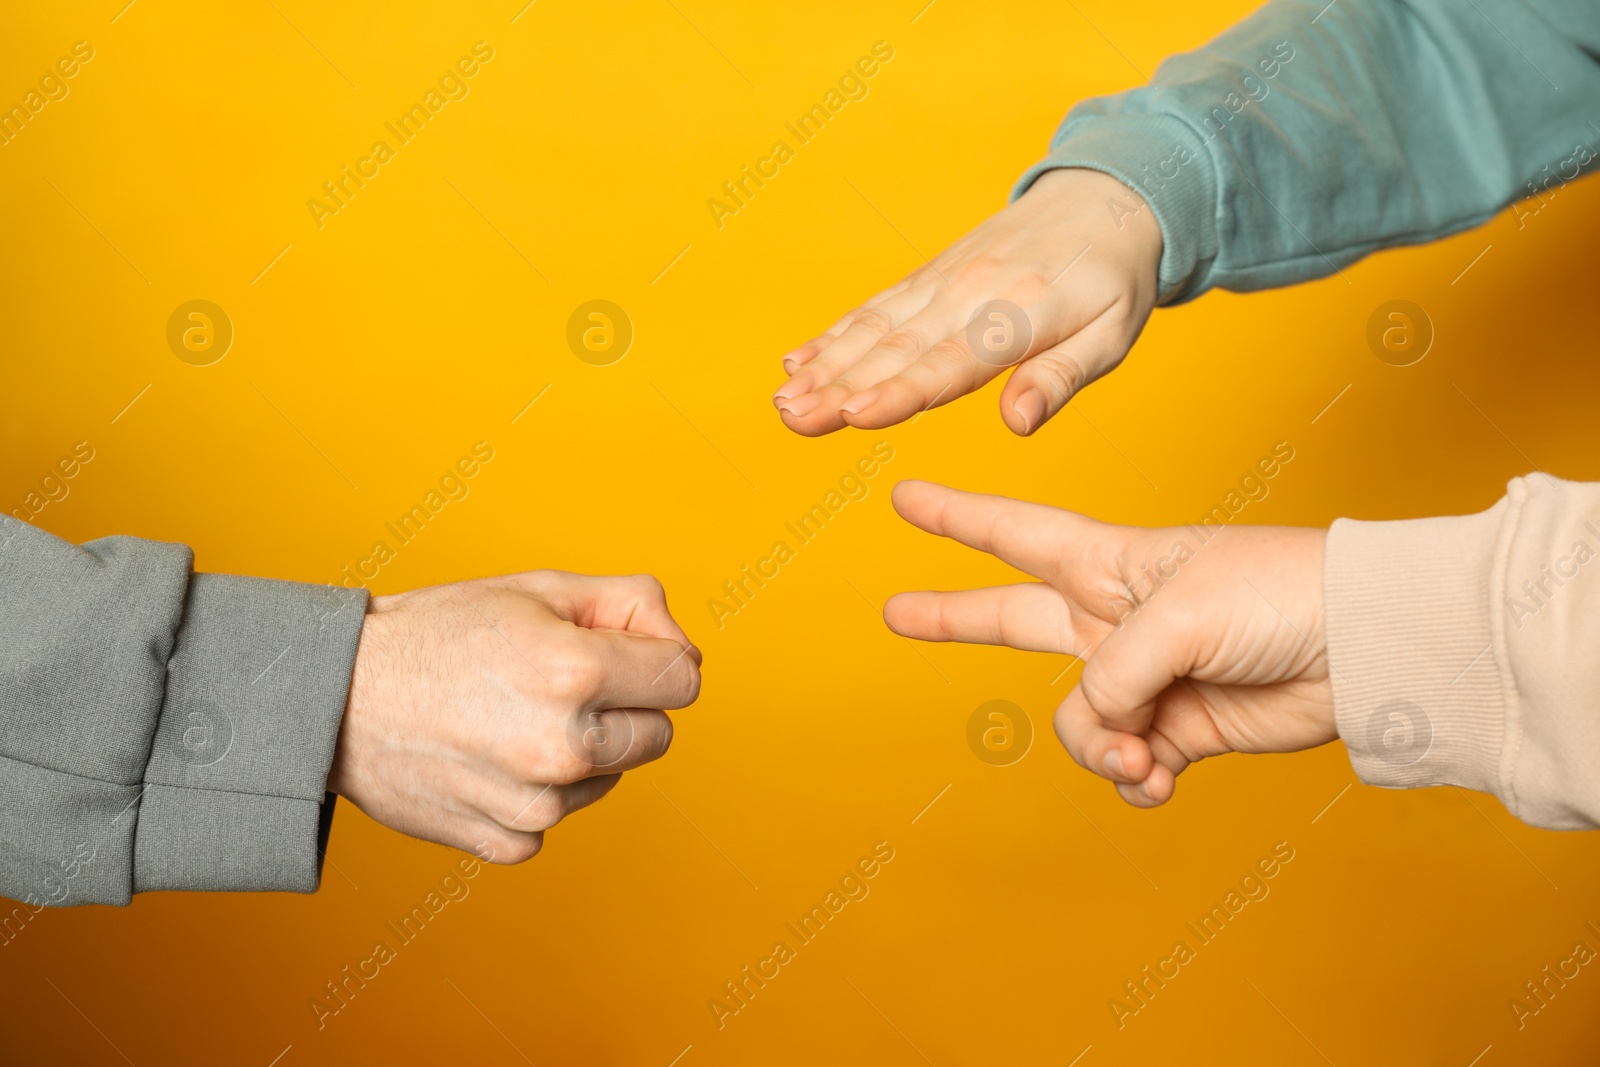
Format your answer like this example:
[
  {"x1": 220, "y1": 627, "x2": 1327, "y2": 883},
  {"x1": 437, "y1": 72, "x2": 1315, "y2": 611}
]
[{"x1": 0, "y1": 0, "x2": 1600, "y2": 1067}]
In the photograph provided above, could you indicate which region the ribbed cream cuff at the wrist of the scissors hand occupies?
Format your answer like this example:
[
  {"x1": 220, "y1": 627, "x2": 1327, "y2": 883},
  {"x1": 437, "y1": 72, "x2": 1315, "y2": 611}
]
[{"x1": 1323, "y1": 501, "x2": 1509, "y2": 800}]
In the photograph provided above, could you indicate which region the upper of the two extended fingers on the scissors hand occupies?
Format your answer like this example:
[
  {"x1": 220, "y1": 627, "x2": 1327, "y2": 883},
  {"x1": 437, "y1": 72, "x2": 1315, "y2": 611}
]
[{"x1": 893, "y1": 480, "x2": 1117, "y2": 581}]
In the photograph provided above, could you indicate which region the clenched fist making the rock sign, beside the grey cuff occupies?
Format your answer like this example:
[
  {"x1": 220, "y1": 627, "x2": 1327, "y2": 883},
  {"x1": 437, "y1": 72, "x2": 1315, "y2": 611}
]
[{"x1": 328, "y1": 571, "x2": 701, "y2": 862}]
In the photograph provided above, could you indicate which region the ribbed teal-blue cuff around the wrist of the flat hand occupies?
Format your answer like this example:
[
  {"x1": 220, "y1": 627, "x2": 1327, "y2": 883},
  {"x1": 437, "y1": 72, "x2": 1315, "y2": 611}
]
[{"x1": 1011, "y1": 114, "x2": 1218, "y2": 304}]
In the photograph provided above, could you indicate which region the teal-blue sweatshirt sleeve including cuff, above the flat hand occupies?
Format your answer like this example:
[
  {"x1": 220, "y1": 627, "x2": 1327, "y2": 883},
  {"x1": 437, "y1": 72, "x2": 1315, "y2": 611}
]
[{"x1": 1013, "y1": 0, "x2": 1600, "y2": 304}]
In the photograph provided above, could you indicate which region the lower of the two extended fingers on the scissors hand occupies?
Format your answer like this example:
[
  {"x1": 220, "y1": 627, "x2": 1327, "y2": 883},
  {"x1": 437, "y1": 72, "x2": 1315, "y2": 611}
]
[{"x1": 883, "y1": 582, "x2": 1080, "y2": 654}]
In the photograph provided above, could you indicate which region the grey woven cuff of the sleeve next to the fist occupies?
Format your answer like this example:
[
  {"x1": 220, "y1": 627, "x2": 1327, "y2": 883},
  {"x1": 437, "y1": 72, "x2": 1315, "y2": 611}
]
[{"x1": 134, "y1": 574, "x2": 366, "y2": 893}]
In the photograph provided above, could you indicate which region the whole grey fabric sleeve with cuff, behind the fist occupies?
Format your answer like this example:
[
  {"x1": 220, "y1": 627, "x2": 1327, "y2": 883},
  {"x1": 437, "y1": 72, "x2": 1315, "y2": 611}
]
[{"x1": 0, "y1": 515, "x2": 366, "y2": 907}]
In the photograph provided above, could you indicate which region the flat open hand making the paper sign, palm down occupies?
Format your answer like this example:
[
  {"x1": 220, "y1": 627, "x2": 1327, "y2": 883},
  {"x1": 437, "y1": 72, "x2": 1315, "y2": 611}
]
[{"x1": 773, "y1": 168, "x2": 1162, "y2": 437}]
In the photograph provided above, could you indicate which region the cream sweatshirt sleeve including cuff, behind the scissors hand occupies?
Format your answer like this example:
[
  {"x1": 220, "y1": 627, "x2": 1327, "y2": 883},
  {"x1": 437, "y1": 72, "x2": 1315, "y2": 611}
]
[{"x1": 1323, "y1": 474, "x2": 1600, "y2": 830}]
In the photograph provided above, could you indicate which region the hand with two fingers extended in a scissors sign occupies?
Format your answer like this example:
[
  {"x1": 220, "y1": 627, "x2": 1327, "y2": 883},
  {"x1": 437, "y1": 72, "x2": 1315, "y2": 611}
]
[{"x1": 883, "y1": 482, "x2": 1338, "y2": 808}]
